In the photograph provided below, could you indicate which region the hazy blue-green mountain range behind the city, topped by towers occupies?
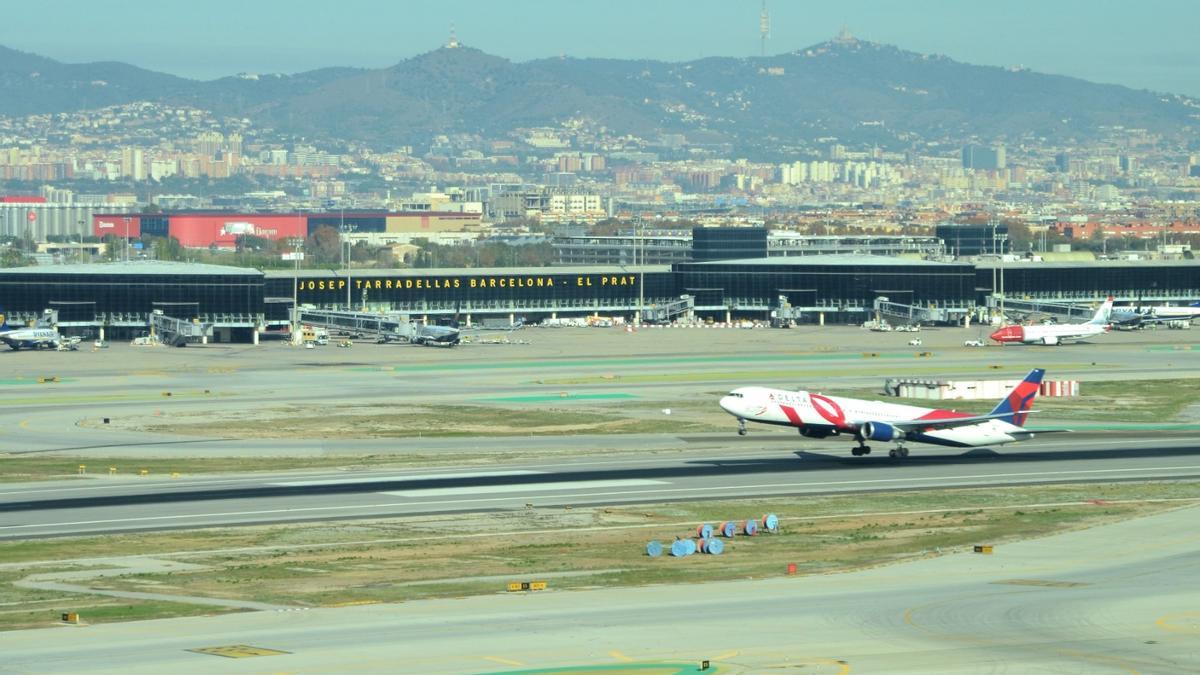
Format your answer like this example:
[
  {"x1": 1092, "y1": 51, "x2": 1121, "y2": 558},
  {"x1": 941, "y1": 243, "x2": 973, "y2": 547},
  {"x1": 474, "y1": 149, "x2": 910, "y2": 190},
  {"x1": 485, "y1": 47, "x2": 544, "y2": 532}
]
[{"x1": 0, "y1": 36, "x2": 1200, "y2": 156}]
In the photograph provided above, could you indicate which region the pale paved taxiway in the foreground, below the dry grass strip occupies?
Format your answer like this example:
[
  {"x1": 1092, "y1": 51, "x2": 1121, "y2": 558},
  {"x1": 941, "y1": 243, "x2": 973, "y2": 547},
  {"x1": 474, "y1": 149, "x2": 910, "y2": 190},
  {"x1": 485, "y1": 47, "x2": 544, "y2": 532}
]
[{"x1": 0, "y1": 508, "x2": 1200, "y2": 674}]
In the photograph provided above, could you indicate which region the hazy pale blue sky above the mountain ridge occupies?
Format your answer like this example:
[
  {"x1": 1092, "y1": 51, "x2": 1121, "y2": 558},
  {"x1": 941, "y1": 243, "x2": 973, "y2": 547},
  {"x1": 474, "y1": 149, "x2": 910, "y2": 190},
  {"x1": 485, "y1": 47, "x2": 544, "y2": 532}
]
[{"x1": 9, "y1": 0, "x2": 1200, "y2": 96}]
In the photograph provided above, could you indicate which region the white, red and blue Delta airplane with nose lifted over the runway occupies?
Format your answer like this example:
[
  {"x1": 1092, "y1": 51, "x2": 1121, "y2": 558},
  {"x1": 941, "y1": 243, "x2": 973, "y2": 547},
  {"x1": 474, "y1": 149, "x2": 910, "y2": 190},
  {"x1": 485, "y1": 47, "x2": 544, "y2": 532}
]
[{"x1": 721, "y1": 368, "x2": 1051, "y2": 458}]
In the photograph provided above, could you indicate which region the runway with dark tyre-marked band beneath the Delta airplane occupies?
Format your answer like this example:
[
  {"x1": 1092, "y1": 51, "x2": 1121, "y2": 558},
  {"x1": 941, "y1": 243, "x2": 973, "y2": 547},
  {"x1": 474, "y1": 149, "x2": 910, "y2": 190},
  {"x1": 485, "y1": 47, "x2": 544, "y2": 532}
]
[{"x1": 0, "y1": 432, "x2": 1200, "y2": 539}]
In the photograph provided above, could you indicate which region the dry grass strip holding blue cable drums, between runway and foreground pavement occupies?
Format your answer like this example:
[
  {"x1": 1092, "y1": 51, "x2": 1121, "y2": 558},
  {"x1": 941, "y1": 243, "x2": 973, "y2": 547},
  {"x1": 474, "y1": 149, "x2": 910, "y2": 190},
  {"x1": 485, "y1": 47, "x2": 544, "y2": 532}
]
[{"x1": 0, "y1": 482, "x2": 1200, "y2": 629}]
